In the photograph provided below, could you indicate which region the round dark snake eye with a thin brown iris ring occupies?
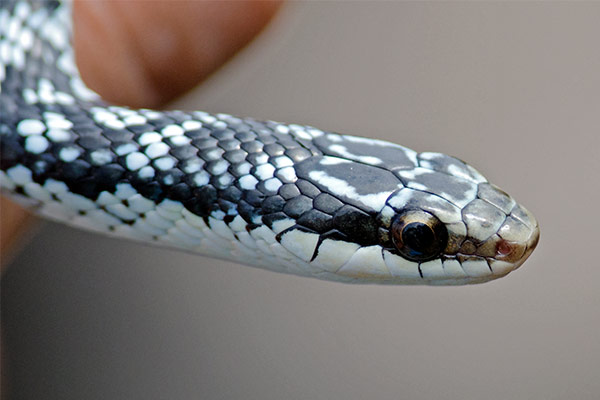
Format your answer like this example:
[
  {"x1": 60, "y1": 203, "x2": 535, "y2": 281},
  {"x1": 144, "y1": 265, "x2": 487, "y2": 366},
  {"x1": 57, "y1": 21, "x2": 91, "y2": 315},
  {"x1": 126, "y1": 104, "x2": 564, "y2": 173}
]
[{"x1": 391, "y1": 210, "x2": 448, "y2": 261}]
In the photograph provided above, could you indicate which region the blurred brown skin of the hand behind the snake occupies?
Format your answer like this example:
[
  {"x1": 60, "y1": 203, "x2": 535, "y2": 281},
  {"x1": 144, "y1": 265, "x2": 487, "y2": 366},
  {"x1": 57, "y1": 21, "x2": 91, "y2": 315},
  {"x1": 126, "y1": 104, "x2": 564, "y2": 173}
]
[{"x1": 0, "y1": 0, "x2": 281, "y2": 268}]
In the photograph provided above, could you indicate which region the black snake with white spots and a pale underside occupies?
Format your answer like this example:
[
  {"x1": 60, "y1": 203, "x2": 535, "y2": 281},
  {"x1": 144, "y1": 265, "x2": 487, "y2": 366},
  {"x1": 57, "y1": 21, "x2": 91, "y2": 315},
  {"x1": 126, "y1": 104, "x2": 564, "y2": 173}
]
[{"x1": 0, "y1": 0, "x2": 539, "y2": 285}]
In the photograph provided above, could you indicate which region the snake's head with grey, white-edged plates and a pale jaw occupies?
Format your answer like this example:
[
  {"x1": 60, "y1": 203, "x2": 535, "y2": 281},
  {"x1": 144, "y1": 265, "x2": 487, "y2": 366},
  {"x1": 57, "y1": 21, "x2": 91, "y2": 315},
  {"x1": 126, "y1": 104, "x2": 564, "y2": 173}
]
[{"x1": 281, "y1": 134, "x2": 539, "y2": 285}]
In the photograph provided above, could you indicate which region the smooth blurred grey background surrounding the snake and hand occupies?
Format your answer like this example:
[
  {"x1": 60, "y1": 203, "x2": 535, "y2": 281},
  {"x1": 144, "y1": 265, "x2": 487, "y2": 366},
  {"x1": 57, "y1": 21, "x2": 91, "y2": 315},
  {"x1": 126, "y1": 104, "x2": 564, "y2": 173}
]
[{"x1": 2, "y1": 2, "x2": 600, "y2": 400}]
